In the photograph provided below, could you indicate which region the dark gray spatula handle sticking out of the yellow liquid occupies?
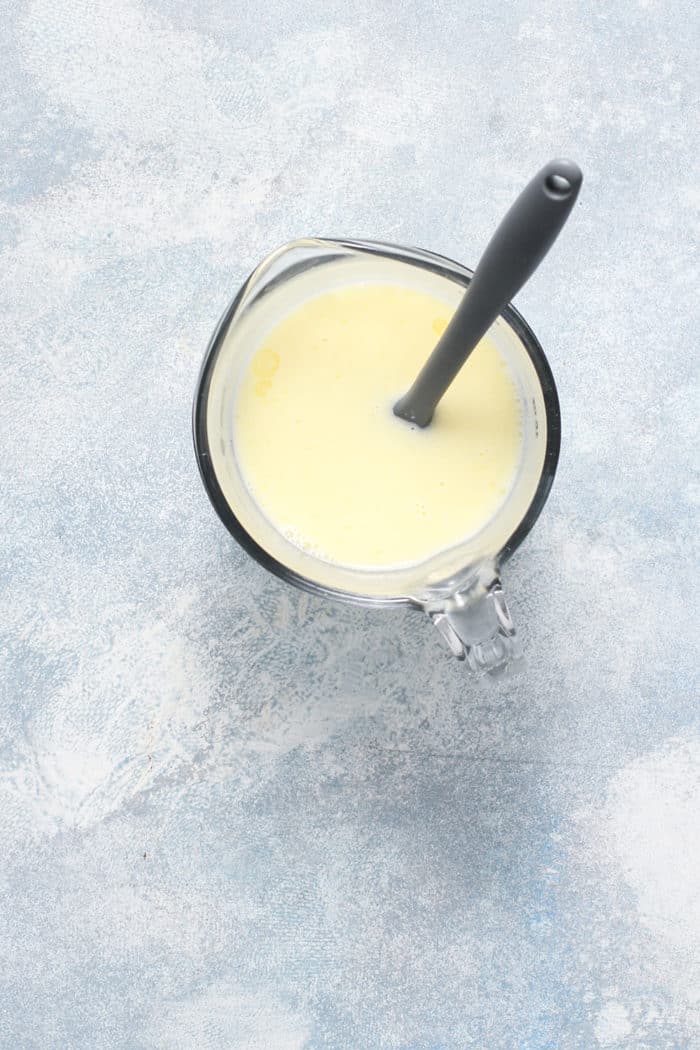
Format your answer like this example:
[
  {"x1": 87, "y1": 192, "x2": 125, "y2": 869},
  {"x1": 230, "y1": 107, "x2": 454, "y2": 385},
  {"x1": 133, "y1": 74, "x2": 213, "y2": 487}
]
[{"x1": 394, "y1": 161, "x2": 584, "y2": 426}]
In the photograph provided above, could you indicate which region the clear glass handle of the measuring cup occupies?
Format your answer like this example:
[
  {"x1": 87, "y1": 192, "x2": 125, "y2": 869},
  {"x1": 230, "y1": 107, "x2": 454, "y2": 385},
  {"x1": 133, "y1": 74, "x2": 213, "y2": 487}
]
[{"x1": 425, "y1": 572, "x2": 522, "y2": 675}]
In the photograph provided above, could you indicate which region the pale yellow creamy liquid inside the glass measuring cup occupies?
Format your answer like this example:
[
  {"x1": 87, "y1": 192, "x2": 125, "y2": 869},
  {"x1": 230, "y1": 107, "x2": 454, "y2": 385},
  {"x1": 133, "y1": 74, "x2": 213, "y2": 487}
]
[{"x1": 234, "y1": 285, "x2": 522, "y2": 568}]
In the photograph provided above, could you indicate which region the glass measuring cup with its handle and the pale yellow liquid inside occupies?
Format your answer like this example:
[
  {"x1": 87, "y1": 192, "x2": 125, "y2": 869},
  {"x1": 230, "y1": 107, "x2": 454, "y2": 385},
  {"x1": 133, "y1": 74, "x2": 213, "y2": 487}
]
[{"x1": 194, "y1": 160, "x2": 579, "y2": 671}]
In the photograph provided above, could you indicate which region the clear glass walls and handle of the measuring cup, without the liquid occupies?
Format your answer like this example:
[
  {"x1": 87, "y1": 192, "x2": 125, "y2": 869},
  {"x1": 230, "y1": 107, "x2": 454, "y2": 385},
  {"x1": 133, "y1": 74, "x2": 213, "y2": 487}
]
[{"x1": 193, "y1": 238, "x2": 560, "y2": 672}]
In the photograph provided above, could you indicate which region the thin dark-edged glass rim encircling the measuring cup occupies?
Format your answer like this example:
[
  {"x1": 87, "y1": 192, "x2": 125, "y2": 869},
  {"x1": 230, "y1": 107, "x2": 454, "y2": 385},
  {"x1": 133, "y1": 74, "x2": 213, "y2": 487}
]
[{"x1": 192, "y1": 237, "x2": 561, "y2": 607}]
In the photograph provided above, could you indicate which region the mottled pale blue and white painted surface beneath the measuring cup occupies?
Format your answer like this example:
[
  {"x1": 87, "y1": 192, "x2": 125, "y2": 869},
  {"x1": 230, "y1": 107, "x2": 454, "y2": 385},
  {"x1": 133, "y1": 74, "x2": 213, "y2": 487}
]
[{"x1": 0, "y1": 0, "x2": 700, "y2": 1050}]
